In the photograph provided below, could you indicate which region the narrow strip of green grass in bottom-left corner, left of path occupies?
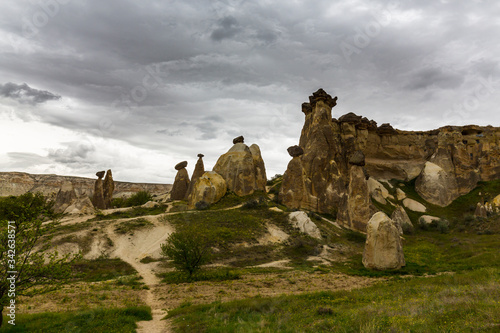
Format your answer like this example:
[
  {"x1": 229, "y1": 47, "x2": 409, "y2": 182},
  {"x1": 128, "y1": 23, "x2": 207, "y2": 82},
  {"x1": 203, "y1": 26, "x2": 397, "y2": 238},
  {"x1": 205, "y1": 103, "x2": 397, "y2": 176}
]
[{"x1": 0, "y1": 306, "x2": 152, "y2": 333}]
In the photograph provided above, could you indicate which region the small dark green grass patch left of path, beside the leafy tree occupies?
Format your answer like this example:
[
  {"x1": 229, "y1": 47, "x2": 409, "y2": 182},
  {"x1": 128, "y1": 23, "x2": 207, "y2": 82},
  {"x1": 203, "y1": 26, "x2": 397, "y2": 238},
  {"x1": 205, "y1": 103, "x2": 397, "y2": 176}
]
[{"x1": 71, "y1": 259, "x2": 137, "y2": 282}]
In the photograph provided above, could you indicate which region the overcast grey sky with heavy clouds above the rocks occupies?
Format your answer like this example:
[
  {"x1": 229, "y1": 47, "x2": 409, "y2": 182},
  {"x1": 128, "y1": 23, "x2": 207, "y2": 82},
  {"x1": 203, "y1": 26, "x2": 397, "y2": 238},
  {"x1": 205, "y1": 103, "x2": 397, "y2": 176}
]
[{"x1": 0, "y1": 0, "x2": 500, "y2": 183}]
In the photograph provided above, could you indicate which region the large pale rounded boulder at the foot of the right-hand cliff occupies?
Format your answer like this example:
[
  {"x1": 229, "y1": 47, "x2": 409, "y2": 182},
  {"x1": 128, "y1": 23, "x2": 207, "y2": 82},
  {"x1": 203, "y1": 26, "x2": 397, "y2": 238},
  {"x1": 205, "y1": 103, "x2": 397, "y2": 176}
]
[{"x1": 415, "y1": 162, "x2": 458, "y2": 207}]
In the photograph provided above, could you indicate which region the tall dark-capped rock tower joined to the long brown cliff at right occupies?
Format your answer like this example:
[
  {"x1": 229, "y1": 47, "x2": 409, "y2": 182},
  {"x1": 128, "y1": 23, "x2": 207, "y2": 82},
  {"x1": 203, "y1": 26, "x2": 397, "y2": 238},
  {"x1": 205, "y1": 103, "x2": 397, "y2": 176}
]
[{"x1": 280, "y1": 89, "x2": 500, "y2": 230}]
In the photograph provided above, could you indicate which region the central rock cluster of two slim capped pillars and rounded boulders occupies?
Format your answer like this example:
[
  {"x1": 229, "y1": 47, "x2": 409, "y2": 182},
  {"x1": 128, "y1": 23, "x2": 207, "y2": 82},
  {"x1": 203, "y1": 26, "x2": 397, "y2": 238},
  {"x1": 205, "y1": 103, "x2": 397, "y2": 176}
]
[{"x1": 170, "y1": 136, "x2": 267, "y2": 208}]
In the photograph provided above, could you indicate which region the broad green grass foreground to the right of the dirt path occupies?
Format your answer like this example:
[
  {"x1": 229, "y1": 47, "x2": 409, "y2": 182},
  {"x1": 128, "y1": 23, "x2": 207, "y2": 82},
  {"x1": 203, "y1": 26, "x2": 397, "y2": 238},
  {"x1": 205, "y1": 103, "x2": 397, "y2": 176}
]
[{"x1": 168, "y1": 268, "x2": 500, "y2": 333}]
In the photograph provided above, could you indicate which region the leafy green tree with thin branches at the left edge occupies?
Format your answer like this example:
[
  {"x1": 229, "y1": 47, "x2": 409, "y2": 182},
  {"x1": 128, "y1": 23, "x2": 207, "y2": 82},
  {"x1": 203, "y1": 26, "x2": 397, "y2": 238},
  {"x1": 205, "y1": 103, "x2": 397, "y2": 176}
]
[{"x1": 0, "y1": 193, "x2": 78, "y2": 326}]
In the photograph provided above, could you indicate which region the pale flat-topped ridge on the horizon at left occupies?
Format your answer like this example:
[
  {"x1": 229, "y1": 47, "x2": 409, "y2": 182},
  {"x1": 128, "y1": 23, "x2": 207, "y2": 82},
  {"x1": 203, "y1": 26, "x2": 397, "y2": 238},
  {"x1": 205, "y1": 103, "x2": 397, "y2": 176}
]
[{"x1": 0, "y1": 172, "x2": 172, "y2": 198}]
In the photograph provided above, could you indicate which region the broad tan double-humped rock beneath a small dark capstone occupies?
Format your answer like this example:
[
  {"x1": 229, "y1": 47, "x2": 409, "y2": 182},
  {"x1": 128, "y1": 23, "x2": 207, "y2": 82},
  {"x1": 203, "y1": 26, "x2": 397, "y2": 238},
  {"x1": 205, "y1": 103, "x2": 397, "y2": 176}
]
[{"x1": 213, "y1": 142, "x2": 267, "y2": 196}]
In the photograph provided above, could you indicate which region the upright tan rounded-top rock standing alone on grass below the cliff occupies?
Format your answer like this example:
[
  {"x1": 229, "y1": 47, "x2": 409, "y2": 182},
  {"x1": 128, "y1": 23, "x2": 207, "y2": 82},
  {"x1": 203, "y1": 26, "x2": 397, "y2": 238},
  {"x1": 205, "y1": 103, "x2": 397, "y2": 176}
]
[{"x1": 363, "y1": 212, "x2": 406, "y2": 270}]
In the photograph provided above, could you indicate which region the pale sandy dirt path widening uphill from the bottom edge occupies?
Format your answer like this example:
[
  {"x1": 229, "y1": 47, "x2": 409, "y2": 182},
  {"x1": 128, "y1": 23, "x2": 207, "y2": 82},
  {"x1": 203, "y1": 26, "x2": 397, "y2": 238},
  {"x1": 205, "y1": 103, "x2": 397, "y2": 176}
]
[{"x1": 106, "y1": 218, "x2": 173, "y2": 333}]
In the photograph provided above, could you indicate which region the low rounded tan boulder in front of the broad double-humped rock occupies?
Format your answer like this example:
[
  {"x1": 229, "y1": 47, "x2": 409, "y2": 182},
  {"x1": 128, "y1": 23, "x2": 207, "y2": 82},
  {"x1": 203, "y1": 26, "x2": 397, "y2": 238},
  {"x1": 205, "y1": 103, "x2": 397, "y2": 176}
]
[{"x1": 188, "y1": 171, "x2": 227, "y2": 209}]
